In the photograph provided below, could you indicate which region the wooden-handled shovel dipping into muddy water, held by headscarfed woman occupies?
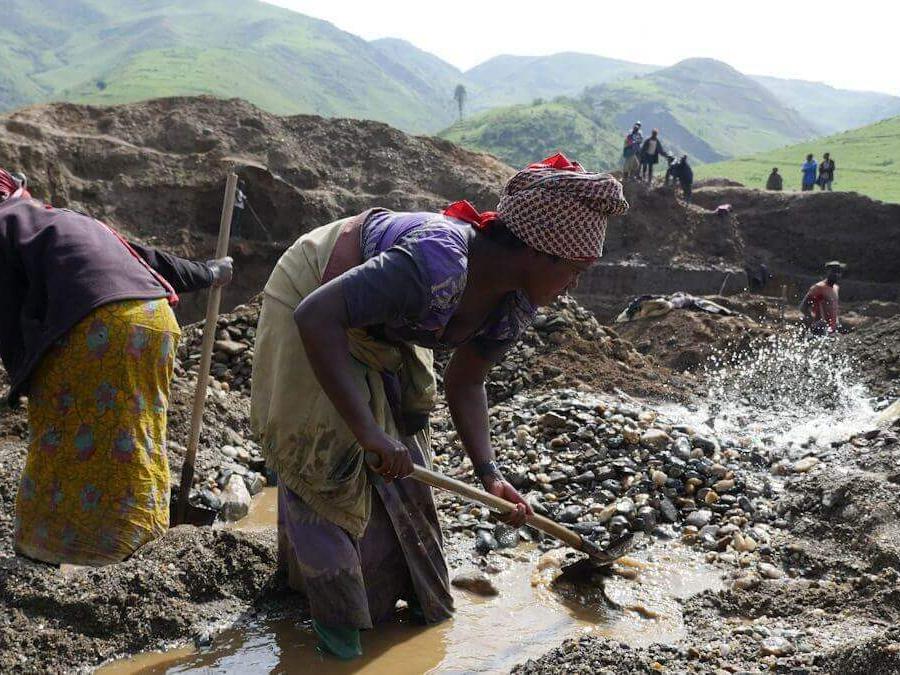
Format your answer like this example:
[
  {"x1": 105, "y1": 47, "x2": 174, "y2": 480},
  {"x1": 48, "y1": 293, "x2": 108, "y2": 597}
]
[{"x1": 366, "y1": 452, "x2": 632, "y2": 576}]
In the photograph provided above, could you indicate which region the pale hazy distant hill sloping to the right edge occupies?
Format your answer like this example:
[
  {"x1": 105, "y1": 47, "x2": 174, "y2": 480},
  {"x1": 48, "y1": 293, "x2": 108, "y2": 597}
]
[{"x1": 752, "y1": 76, "x2": 900, "y2": 134}]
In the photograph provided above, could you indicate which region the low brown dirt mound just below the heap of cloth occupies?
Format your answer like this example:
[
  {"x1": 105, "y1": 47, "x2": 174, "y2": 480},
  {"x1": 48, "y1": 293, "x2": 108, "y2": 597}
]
[{"x1": 616, "y1": 309, "x2": 772, "y2": 371}]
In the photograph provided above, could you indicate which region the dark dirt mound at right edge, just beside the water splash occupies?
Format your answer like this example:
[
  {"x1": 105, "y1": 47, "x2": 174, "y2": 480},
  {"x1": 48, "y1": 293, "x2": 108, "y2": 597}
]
[{"x1": 844, "y1": 315, "x2": 900, "y2": 397}]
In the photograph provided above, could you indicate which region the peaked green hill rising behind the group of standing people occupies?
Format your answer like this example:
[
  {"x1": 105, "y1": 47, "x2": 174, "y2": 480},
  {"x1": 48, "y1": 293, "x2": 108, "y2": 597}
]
[{"x1": 440, "y1": 59, "x2": 813, "y2": 168}]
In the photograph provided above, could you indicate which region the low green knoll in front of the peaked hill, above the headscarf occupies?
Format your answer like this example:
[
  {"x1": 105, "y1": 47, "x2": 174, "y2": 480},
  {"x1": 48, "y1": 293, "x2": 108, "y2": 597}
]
[{"x1": 440, "y1": 100, "x2": 621, "y2": 170}]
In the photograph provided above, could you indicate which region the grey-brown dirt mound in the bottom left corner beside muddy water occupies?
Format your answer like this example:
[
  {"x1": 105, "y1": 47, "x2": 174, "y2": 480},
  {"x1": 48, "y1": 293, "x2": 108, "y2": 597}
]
[{"x1": 0, "y1": 526, "x2": 280, "y2": 673}]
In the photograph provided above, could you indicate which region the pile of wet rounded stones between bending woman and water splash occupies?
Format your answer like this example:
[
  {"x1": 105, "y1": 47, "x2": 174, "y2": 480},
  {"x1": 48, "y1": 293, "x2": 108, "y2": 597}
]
[{"x1": 435, "y1": 390, "x2": 774, "y2": 560}]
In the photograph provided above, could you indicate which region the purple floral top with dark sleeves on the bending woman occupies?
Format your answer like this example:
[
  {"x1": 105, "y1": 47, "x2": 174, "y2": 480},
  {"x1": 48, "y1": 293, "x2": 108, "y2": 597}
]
[{"x1": 341, "y1": 211, "x2": 535, "y2": 360}]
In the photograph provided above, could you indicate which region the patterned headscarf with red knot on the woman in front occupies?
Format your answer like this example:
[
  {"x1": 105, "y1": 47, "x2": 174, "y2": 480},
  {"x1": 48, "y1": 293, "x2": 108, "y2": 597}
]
[{"x1": 444, "y1": 153, "x2": 628, "y2": 260}]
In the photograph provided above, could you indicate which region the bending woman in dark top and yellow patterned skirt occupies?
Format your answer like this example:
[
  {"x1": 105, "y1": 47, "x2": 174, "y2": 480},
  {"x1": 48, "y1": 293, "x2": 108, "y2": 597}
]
[{"x1": 0, "y1": 169, "x2": 232, "y2": 565}]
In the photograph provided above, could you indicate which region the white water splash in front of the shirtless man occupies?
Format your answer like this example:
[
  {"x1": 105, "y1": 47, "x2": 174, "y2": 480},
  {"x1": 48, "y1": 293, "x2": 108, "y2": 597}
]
[{"x1": 676, "y1": 330, "x2": 877, "y2": 446}]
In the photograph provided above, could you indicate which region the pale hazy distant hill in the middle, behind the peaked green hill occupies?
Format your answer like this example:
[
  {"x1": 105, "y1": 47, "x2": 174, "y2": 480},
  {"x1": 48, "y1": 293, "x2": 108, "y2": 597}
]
[{"x1": 465, "y1": 52, "x2": 658, "y2": 110}]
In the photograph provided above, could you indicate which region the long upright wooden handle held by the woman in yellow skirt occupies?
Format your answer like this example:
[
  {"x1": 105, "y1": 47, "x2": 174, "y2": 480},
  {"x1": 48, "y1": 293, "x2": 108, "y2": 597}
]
[{"x1": 175, "y1": 173, "x2": 237, "y2": 525}]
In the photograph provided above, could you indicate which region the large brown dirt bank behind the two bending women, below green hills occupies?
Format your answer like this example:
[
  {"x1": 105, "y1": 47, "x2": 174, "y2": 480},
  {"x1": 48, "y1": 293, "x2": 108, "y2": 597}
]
[{"x1": 0, "y1": 97, "x2": 512, "y2": 320}]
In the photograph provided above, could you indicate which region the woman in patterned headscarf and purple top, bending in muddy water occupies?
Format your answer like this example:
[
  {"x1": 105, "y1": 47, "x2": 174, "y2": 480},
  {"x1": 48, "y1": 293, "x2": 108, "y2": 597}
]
[{"x1": 251, "y1": 155, "x2": 628, "y2": 658}]
